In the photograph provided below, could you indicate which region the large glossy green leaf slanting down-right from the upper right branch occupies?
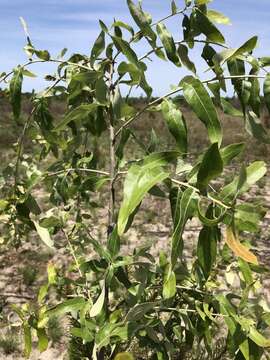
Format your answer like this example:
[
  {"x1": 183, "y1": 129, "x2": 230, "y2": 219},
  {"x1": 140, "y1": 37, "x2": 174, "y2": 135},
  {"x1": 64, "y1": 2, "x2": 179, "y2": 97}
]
[{"x1": 181, "y1": 76, "x2": 222, "y2": 144}]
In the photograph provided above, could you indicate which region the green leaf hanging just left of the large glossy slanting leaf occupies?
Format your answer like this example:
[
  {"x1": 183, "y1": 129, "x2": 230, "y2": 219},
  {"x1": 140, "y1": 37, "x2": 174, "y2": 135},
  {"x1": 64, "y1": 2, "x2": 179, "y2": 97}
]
[{"x1": 161, "y1": 100, "x2": 188, "y2": 154}]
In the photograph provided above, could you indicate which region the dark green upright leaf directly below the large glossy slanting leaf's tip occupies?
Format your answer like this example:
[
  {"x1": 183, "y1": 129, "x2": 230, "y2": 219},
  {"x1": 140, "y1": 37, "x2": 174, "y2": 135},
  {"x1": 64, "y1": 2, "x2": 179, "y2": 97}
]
[{"x1": 197, "y1": 143, "x2": 223, "y2": 191}]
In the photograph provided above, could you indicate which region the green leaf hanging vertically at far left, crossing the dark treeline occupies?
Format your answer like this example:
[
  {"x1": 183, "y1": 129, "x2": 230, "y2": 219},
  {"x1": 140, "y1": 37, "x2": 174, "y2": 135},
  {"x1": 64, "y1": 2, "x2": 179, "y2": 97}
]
[{"x1": 9, "y1": 68, "x2": 23, "y2": 120}]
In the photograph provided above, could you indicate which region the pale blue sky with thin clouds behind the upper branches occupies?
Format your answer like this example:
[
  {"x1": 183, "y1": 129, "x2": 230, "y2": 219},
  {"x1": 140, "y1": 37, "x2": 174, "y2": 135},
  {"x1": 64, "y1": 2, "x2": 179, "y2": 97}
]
[{"x1": 0, "y1": 0, "x2": 270, "y2": 94}]
